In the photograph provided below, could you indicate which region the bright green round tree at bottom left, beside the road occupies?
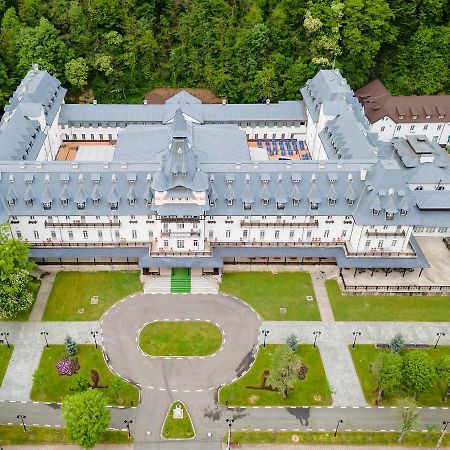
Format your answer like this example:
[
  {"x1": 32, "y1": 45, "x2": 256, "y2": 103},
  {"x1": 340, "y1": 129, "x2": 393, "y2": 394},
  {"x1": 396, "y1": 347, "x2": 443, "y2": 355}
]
[{"x1": 61, "y1": 389, "x2": 111, "y2": 449}]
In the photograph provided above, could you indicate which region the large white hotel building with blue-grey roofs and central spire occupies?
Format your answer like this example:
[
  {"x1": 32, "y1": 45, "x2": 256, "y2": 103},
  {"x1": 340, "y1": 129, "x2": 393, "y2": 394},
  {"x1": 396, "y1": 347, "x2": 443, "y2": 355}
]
[{"x1": 0, "y1": 68, "x2": 450, "y2": 273}]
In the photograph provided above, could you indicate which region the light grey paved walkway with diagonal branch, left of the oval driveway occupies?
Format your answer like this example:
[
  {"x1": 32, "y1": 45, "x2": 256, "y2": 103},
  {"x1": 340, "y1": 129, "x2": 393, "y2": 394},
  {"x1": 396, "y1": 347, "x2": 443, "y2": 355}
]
[{"x1": 0, "y1": 322, "x2": 99, "y2": 401}]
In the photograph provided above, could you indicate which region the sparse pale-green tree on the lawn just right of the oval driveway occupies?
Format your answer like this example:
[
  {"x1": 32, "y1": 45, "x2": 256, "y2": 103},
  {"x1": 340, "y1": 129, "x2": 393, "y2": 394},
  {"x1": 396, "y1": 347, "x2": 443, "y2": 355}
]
[{"x1": 267, "y1": 345, "x2": 302, "y2": 400}]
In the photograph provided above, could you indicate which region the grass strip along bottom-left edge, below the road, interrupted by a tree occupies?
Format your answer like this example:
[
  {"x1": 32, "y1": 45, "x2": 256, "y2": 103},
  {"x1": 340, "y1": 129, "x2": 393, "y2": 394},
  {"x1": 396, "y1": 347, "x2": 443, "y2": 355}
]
[{"x1": 0, "y1": 425, "x2": 134, "y2": 445}]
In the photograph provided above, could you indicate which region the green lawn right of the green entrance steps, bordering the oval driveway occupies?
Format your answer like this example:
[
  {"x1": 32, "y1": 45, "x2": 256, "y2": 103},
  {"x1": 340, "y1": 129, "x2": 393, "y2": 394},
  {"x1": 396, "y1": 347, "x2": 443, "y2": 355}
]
[{"x1": 220, "y1": 272, "x2": 320, "y2": 320}]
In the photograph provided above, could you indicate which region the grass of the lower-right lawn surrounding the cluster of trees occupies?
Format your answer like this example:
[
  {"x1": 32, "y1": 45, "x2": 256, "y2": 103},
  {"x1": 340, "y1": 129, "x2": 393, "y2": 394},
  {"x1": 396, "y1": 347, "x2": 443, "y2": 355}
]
[{"x1": 350, "y1": 345, "x2": 450, "y2": 406}]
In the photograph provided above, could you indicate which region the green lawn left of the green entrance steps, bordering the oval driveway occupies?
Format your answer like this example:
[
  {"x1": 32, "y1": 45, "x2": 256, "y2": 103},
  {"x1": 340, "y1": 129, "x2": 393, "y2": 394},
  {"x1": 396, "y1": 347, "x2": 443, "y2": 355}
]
[{"x1": 42, "y1": 272, "x2": 142, "y2": 320}]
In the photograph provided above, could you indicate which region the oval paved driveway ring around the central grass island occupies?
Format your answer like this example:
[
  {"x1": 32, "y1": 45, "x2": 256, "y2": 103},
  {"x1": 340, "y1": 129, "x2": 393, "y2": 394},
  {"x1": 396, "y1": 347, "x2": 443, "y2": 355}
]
[{"x1": 100, "y1": 294, "x2": 261, "y2": 392}]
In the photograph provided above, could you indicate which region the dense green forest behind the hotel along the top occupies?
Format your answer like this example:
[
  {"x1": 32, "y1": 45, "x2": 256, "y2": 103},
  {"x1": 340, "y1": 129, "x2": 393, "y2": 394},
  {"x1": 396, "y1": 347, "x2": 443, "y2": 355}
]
[{"x1": 0, "y1": 0, "x2": 450, "y2": 106}]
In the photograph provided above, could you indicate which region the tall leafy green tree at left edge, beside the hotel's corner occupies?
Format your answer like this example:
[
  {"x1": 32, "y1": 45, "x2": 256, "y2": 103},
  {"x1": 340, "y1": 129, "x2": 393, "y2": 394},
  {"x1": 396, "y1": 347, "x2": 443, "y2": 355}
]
[{"x1": 0, "y1": 225, "x2": 34, "y2": 317}]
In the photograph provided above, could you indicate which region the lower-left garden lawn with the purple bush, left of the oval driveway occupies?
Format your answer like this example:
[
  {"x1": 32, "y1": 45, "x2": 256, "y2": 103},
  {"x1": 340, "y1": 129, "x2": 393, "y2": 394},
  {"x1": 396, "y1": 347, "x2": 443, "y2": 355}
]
[{"x1": 30, "y1": 345, "x2": 139, "y2": 406}]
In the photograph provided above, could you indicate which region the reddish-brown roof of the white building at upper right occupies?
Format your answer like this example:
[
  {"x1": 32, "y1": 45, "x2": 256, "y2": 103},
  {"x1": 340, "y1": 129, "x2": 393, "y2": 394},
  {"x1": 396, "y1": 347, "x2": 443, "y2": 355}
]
[{"x1": 355, "y1": 80, "x2": 450, "y2": 123}]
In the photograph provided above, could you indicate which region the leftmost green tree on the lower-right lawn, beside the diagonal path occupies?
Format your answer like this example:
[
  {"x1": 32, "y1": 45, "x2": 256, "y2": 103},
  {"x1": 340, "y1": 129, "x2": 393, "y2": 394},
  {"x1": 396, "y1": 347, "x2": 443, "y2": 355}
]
[{"x1": 370, "y1": 353, "x2": 402, "y2": 404}]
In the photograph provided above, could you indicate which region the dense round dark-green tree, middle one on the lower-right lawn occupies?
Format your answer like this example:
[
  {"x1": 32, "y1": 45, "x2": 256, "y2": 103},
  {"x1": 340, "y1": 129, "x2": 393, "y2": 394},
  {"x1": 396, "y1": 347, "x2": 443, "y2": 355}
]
[{"x1": 402, "y1": 350, "x2": 436, "y2": 399}]
